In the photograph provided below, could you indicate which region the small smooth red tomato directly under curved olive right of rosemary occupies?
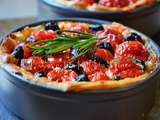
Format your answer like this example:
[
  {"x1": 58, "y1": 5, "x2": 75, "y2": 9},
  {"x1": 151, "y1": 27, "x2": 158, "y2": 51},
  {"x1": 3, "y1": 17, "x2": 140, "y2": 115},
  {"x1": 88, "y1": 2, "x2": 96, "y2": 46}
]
[{"x1": 95, "y1": 48, "x2": 113, "y2": 61}]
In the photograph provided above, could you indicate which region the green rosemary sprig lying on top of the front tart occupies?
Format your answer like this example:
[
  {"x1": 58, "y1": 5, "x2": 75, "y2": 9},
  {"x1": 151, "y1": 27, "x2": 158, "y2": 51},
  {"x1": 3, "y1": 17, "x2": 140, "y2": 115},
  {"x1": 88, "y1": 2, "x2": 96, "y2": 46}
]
[{"x1": 29, "y1": 30, "x2": 106, "y2": 59}]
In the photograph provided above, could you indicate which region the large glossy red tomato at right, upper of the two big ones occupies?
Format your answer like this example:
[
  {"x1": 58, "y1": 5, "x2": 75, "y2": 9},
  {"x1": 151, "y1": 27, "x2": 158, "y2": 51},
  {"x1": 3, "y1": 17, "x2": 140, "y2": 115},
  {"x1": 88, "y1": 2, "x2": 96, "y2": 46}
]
[{"x1": 115, "y1": 41, "x2": 149, "y2": 61}]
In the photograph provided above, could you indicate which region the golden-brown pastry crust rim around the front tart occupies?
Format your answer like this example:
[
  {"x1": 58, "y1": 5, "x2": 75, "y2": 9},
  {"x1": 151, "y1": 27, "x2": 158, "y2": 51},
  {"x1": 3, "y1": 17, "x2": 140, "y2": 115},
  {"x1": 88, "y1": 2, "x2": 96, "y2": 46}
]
[{"x1": 0, "y1": 22, "x2": 158, "y2": 91}]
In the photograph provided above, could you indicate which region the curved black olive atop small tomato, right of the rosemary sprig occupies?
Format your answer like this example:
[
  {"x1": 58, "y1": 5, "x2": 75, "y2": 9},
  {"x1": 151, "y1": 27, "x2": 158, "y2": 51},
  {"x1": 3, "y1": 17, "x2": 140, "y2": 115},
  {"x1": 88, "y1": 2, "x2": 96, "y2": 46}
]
[{"x1": 96, "y1": 41, "x2": 114, "y2": 54}]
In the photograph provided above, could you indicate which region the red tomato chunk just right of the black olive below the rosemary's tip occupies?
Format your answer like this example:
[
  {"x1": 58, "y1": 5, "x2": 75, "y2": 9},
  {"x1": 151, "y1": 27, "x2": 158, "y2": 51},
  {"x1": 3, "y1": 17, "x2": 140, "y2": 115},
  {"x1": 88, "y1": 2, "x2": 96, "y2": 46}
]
[{"x1": 81, "y1": 60, "x2": 105, "y2": 75}]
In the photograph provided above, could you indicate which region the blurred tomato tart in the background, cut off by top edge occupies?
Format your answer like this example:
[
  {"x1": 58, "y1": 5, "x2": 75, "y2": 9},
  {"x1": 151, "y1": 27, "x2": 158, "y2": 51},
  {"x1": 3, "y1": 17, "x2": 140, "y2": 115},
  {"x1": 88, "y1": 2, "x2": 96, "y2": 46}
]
[{"x1": 57, "y1": 0, "x2": 156, "y2": 11}]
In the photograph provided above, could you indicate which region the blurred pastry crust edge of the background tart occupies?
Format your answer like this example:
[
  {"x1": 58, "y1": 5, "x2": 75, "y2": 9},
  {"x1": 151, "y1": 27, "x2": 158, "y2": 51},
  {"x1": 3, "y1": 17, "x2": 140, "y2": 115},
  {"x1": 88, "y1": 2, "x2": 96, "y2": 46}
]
[{"x1": 58, "y1": 0, "x2": 156, "y2": 11}]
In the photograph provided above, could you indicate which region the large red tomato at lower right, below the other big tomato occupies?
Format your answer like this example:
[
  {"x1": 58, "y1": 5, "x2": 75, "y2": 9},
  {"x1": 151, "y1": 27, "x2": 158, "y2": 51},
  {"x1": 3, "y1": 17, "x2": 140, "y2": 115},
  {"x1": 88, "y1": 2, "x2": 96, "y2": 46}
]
[{"x1": 108, "y1": 60, "x2": 144, "y2": 78}]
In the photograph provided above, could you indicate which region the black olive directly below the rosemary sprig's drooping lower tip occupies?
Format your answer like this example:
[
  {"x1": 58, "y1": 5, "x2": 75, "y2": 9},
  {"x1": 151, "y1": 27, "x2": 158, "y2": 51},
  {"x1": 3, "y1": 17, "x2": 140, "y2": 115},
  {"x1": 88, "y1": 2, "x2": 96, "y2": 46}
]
[{"x1": 65, "y1": 64, "x2": 83, "y2": 75}]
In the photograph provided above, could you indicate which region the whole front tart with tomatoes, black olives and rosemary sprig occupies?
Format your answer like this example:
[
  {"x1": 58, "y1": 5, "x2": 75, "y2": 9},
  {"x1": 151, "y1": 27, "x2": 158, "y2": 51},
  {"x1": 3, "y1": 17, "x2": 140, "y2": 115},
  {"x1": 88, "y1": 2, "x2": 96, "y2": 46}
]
[{"x1": 0, "y1": 21, "x2": 158, "y2": 91}]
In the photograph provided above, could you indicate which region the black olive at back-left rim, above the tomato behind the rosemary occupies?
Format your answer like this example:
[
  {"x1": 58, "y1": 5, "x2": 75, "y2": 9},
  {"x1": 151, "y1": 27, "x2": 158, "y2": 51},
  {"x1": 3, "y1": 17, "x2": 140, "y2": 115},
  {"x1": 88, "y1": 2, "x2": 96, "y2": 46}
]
[{"x1": 45, "y1": 22, "x2": 60, "y2": 31}]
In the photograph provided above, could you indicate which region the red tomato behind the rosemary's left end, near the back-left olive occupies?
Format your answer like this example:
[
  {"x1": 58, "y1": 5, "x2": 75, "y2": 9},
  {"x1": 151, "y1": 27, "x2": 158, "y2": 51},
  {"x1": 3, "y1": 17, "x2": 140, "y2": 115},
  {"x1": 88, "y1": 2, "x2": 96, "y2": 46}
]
[{"x1": 31, "y1": 30, "x2": 57, "y2": 40}]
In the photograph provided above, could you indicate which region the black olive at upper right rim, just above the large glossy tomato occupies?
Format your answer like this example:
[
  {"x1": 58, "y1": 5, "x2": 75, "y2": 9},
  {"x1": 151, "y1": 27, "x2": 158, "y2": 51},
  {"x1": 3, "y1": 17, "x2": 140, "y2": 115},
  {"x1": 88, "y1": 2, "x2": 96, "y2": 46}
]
[{"x1": 125, "y1": 33, "x2": 144, "y2": 43}]
